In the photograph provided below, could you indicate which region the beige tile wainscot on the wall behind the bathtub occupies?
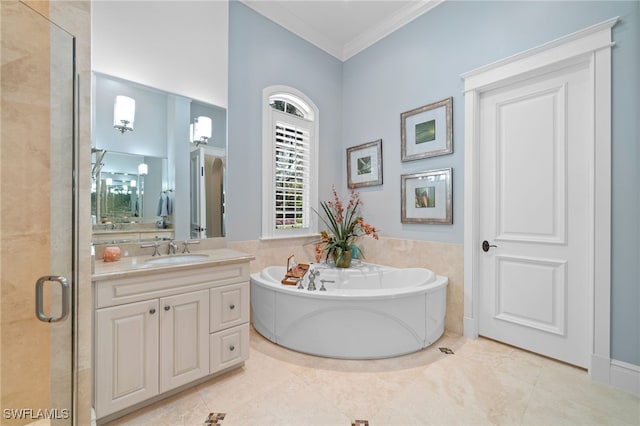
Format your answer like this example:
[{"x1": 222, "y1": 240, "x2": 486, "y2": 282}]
[{"x1": 228, "y1": 237, "x2": 464, "y2": 334}]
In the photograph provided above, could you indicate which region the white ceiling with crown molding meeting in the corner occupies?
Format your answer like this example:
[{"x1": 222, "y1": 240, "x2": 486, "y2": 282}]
[{"x1": 240, "y1": 0, "x2": 444, "y2": 61}]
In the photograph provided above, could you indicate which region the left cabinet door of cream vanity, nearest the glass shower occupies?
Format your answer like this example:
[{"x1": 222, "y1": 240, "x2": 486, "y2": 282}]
[{"x1": 95, "y1": 299, "x2": 159, "y2": 418}]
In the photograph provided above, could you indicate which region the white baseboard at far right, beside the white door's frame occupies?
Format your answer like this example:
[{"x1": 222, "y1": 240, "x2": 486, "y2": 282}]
[{"x1": 589, "y1": 355, "x2": 640, "y2": 396}]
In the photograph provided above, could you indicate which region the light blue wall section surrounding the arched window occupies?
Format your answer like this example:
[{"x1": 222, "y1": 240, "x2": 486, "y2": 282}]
[{"x1": 225, "y1": 1, "x2": 343, "y2": 240}]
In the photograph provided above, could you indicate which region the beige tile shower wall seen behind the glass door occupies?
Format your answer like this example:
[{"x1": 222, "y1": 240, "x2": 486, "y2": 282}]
[{"x1": 0, "y1": 3, "x2": 51, "y2": 416}]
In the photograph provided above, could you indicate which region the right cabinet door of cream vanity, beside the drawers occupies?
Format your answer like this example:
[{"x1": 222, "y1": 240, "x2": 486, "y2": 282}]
[{"x1": 160, "y1": 290, "x2": 209, "y2": 392}]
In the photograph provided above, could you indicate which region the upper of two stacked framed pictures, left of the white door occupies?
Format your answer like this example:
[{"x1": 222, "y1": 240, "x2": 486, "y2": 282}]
[{"x1": 400, "y1": 98, "x2": 453, "y2": 161}]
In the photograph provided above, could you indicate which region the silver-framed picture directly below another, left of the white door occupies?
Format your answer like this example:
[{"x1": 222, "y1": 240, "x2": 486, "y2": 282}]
[{"x1": 401, "y1": 168, "x2": 453, "y2": 225}]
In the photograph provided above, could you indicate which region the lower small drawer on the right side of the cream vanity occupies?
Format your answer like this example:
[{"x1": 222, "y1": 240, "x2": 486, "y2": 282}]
[{"x1": 209, "y1": 323, "x2": 249, "y2": 374}]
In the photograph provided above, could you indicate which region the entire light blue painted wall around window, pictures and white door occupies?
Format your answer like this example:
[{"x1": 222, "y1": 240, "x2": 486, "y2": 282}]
[{"x1": 227, "y1": 1, "x2": 640, "y2": 365}]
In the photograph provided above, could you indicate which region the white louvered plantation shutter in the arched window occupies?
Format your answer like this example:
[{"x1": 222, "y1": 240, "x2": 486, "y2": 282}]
[{"x1": 274, "y1": 117, "x2": 311, "y2": 229}]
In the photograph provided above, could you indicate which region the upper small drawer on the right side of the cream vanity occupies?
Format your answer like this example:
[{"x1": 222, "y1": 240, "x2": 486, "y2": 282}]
[{"x1": 209, "y1": 282, "x2": 250, "y2": 333}]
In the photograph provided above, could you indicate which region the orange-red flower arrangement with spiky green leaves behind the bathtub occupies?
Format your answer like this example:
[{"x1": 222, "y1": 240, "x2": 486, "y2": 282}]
[{"x1": 315, "y1": 187, "x2": 378, "y2": 262}]
